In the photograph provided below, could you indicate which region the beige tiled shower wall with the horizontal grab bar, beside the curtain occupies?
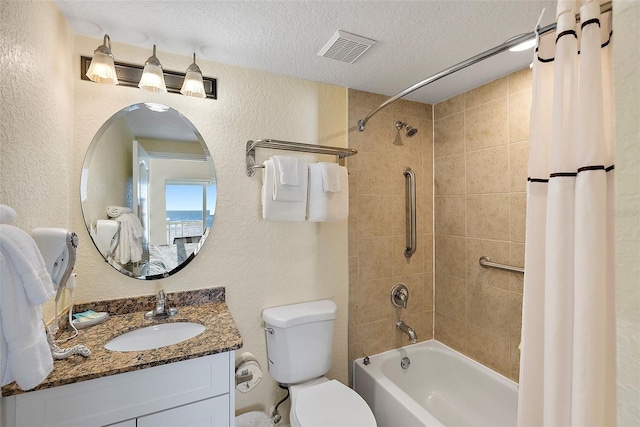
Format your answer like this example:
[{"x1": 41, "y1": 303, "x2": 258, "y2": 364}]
[{"x1": 434, "y1": 68, "x2": 531, "y2": 381}]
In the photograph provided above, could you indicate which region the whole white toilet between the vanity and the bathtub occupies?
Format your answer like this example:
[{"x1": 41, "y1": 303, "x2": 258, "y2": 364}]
[{"x1": 262, "y1": 300, "x2": 376, "y2": 427}]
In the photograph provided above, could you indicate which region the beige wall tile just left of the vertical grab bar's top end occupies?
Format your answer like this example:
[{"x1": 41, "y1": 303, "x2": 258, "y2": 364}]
[{"x1": 358, "y1": 152, "x2": 394, "y2": 196}]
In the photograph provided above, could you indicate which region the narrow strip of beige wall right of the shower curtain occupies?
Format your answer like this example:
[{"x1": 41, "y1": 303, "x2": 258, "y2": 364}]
[{"x1": 613, "y1": 0, "x2": 640, "y2": 427}]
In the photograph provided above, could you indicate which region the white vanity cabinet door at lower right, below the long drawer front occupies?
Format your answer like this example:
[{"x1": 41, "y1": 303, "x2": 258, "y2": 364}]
[{"x1": 138, "y1": 395, "x2": 229, "y2": 427}]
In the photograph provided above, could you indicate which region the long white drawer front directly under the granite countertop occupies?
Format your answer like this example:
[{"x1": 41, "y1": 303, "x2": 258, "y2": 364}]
[{"x1": 16, "y1": 352, "x2": 233, "y2": 426}]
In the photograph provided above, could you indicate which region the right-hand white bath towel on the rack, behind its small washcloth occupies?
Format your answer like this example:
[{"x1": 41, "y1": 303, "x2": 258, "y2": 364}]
[{"x1": 309, "y1": 163, "x2": 349, "y2": 222}]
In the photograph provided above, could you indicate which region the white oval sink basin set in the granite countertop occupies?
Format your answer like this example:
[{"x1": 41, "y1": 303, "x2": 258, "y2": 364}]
[{"x1": 104, "y1": 322, "x2": 205, "y2": 351}]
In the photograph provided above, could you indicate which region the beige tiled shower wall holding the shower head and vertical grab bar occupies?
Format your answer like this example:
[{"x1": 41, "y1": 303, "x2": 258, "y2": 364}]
[{"x1": 347, "y1": 90, "x2": 433, "y2": 368}]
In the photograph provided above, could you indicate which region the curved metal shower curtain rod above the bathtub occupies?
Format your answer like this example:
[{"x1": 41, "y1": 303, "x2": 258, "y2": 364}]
[{"x1": 358, "y1": 1, "x2": 612, "y2": 132}]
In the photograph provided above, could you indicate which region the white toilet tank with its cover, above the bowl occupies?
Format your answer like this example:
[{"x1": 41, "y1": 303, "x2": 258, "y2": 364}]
[{"x1": 262, "y1": 300, "x2": 337, "y2": 384}]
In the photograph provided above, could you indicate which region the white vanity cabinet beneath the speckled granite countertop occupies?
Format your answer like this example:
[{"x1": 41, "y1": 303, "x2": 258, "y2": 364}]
[{"x1": 2, "y1": 351, "x2": 235, "y2": 427}]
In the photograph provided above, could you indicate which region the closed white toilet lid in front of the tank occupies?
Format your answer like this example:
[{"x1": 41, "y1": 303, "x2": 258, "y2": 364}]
[{"x1": 295, "y1": 380, "x2": 376, "y2": 427}]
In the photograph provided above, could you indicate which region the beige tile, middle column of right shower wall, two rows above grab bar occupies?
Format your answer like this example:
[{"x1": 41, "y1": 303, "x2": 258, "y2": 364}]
[{"x1": 466, "y1": 145, "x2": 509, "y2": 194}]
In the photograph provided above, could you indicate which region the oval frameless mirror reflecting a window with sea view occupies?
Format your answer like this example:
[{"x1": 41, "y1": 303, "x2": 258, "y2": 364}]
[{"x1": 80, "y1": 103, "x2": 216, "y2": 280}]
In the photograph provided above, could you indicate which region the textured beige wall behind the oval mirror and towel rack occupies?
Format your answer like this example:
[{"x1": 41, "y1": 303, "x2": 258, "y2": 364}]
[{"x1": 0, "y1": 1, "x2": 348, "y2": 420}]
